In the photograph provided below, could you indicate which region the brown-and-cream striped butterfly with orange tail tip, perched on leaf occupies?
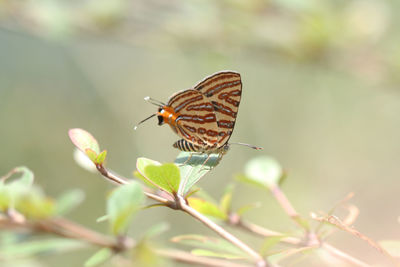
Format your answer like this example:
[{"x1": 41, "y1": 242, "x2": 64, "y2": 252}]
[{"x1": 135, "y1": 71, "x2": 261, "y2": 159}]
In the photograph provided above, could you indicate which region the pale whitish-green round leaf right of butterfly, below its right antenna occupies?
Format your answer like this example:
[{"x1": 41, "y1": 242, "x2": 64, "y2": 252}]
[{"x1": 245, "y1": 156, "x2": 283, "y2": 188}]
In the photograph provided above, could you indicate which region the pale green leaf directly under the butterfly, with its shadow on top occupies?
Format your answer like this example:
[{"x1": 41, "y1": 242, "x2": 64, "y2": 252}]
[{"x1": 174, "y1": 152, "x2": 220, "y2": 196}]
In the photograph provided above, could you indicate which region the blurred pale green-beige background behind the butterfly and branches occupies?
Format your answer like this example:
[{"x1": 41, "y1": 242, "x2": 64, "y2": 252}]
[{"x1": 0, "y1": 0, "x2": 400, "y2": 266}]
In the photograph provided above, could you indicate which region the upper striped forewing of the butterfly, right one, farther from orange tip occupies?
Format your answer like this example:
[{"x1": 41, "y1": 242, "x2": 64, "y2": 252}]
[{"x1": 194, "y1": 71, "x2": 242, "y2": 148}]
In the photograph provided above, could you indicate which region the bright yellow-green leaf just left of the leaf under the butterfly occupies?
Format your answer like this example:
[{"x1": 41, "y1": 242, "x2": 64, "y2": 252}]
[{"x1": 144, "y1": 163, "x2": 181, "y2": 194}]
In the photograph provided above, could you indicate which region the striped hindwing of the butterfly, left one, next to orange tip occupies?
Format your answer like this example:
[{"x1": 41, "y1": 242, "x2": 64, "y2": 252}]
[{"x1": 167, "y1": 89, "x2": 219, "y2": 150}]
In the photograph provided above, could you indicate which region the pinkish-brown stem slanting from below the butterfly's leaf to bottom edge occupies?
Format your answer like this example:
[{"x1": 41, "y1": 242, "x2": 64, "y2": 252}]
[{"x1": 177, "y1": 197, "x2": 268, "y2": 267}]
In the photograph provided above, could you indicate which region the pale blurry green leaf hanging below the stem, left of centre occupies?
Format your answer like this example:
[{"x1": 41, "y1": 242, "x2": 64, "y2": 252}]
[{"x1": 107, "y1": 181, "x2": 145, "y2": 235}]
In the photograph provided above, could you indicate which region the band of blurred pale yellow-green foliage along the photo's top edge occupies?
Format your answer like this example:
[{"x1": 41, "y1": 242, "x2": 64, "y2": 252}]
[{"x1": 0, "y1": 0, "x2": 400, "y2": 85}]
